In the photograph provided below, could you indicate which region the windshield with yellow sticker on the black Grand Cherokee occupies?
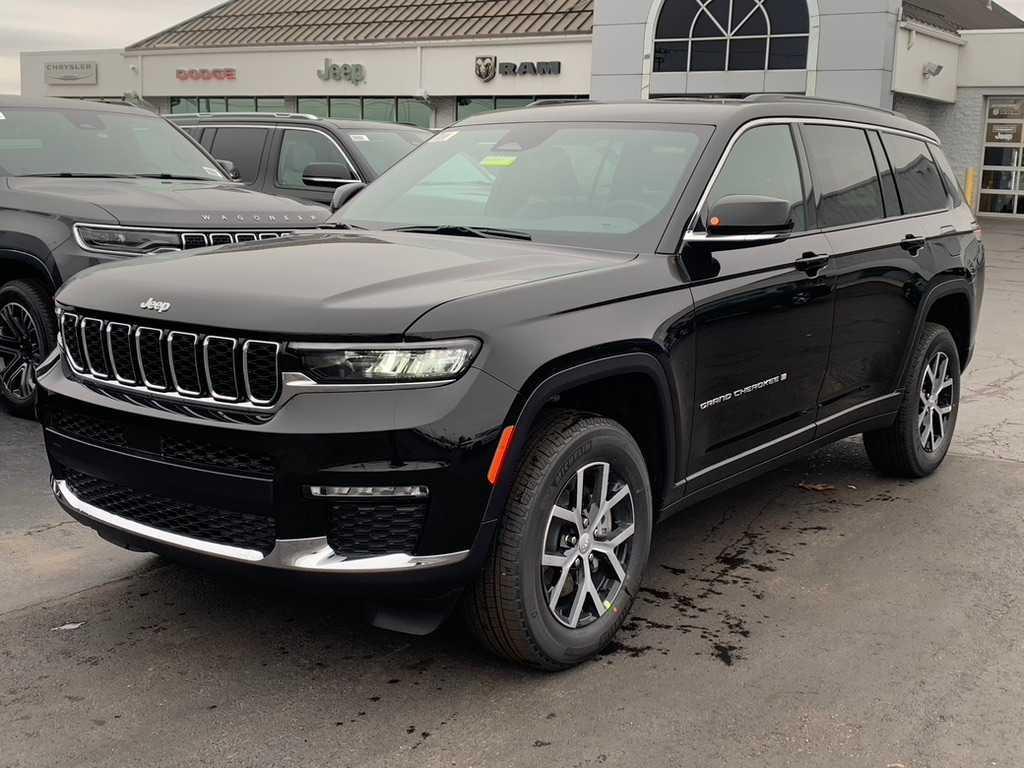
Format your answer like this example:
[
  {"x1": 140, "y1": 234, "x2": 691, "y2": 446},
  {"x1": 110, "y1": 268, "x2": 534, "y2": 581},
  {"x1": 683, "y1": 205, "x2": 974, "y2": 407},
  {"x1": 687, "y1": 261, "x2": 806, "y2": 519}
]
[{"x1": 335, "y1": 123, "x2": 712, "y2": 251}]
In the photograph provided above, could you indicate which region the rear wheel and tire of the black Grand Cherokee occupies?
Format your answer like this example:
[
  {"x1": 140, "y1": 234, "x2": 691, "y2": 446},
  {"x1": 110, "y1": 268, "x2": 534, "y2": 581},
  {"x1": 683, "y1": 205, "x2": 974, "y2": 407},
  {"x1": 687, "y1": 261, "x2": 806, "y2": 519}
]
[{"x1": 864, "y1": 323, "x2": 961, "y2": 478}]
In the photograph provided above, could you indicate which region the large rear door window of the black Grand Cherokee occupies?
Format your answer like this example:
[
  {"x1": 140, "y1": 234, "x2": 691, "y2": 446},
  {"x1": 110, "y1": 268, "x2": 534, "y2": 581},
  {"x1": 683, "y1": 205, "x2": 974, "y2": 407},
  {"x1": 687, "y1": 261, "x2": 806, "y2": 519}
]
[{"x1": 803, "y1": 125, "x2": 885, "y2": 227}]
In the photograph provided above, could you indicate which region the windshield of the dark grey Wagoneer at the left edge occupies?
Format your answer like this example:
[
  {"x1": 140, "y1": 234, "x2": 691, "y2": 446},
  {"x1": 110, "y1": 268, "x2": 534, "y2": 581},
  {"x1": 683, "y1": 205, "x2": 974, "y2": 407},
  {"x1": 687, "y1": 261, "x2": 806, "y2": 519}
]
[{"x1": 0, "y1": 106, "x2": 224, "y2": 181}]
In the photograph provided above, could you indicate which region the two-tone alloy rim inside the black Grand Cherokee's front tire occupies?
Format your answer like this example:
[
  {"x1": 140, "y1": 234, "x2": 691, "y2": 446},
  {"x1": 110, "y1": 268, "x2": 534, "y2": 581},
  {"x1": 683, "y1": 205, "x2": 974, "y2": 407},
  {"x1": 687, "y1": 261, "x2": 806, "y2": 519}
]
[{"x1": 541, "y1": 462, "x2": 636, "y2": 629}]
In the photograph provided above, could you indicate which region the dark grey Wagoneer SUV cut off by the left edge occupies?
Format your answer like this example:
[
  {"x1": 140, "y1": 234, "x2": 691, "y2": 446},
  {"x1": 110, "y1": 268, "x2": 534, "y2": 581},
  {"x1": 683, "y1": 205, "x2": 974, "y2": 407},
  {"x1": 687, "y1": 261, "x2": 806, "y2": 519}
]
[{"x1": 0, "y1": 96, "x2": 328, "y2": 413}]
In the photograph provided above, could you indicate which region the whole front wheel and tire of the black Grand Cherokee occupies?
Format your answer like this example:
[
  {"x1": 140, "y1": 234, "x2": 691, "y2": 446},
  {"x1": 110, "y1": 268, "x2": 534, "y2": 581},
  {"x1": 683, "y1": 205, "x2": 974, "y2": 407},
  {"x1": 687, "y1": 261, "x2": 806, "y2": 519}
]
[{"x1": 464, "y1": 411, "x2": 653, "y2": 671}]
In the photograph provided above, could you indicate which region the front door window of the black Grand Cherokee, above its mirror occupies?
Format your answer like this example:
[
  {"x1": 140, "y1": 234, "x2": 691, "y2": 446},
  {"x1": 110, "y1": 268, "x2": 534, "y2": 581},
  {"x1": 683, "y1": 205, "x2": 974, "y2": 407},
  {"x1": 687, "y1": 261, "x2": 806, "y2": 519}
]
[{"x1": 708, "y1": 125, "x2": 807, "y2": 231}]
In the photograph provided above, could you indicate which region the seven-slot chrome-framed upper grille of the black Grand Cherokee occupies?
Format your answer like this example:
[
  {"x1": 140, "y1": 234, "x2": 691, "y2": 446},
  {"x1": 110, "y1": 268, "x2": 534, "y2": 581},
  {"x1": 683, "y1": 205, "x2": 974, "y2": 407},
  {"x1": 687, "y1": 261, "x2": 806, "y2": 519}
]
[{"x1": 60, "y1": 312, "x2": 281, "y2": 407}]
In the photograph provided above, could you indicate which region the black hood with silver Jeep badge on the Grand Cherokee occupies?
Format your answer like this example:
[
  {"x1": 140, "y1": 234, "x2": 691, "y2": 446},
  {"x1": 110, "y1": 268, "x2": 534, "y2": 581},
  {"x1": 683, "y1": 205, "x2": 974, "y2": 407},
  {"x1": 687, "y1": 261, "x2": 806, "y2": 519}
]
[{"x1": 57, "y1": 232, "x2": 635, "y2": 338}]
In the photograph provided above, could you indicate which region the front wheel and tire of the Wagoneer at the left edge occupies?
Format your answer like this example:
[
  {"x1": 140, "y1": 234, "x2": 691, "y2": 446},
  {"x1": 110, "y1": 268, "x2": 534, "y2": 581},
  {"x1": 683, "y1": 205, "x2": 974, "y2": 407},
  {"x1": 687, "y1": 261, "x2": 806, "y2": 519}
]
[{"x1": 0, "y1": 281, "x2": 57, "y2": 417}]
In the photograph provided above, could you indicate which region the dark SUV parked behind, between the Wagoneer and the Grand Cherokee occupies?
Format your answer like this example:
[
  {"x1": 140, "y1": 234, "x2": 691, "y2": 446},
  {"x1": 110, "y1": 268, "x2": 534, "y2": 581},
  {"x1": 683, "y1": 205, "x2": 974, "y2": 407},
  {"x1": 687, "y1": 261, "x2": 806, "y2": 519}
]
[{"x1": 168, "y1": 113, "x2": 433, "y2": 205}]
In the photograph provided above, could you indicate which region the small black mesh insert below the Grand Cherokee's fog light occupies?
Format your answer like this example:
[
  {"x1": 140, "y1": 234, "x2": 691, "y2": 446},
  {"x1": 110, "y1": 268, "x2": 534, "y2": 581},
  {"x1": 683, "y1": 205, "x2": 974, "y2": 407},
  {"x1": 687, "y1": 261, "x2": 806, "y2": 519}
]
[{"x1": 327, "y1": 502, "x2": 428, "y2": 557}]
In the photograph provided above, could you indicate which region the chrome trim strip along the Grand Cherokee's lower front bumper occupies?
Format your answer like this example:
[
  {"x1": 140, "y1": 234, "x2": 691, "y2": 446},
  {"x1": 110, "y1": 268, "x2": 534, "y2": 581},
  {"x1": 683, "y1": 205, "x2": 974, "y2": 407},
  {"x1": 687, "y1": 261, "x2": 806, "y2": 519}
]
[{"x1": 52, "y1": 479, "x2": 469, "y2": 573}]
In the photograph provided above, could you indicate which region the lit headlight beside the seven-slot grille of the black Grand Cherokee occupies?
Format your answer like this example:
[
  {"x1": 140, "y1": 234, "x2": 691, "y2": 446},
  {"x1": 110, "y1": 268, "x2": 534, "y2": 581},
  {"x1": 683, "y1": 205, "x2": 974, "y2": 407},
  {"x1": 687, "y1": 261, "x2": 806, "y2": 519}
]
[{"x1": 289, "y1": 339, "x2": 480, "y2": 384}]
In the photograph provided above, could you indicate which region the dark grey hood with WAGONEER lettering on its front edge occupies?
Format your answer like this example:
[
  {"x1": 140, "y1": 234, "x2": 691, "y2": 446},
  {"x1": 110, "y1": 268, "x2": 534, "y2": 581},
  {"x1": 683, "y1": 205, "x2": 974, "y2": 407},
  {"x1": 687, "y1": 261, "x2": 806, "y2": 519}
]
[{"x1": 7, "y1": 177, "x2": 331, "y2": 229}]
